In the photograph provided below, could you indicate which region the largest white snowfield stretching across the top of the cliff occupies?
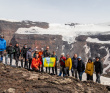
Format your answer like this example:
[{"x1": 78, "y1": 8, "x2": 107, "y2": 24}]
[{"x1": 16, "y1": 24, "x2": 110, "y2": 44}]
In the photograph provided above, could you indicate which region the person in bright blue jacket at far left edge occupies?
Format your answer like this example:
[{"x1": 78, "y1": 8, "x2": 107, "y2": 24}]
[{"x1": 0, "y1": 35, "x2": 6, "y2": 62}]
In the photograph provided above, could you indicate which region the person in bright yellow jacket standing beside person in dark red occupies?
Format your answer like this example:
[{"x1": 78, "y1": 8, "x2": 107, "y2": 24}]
[{"x1": 64, "y1": 54, "x2": 72, "y2": 76}]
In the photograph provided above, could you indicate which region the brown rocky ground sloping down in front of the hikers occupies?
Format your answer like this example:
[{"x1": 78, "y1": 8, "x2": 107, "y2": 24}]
[{"x1": 0, "y1": 63, "x2": 110, "y2": 93}]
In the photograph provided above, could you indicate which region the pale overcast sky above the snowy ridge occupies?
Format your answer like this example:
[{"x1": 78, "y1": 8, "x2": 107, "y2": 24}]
[{"x1": 0, "y1": 0, "x2": 110, "y2": 23}]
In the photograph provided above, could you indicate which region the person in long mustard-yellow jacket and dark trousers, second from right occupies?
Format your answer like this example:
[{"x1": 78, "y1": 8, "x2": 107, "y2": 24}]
[{"x1": 85, "y1": 58, "x2": 94, "y2": 80}]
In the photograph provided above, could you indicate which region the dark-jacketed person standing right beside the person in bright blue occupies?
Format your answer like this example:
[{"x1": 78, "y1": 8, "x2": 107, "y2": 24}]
[{"x1": 5, "y1": 43, "x2": 15, "y2": 66}]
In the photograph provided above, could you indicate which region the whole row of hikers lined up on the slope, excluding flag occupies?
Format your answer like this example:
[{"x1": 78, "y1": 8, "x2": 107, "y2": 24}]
[{"x1": 0, "y1": 35, "x2": 103, "y2": 83}]
